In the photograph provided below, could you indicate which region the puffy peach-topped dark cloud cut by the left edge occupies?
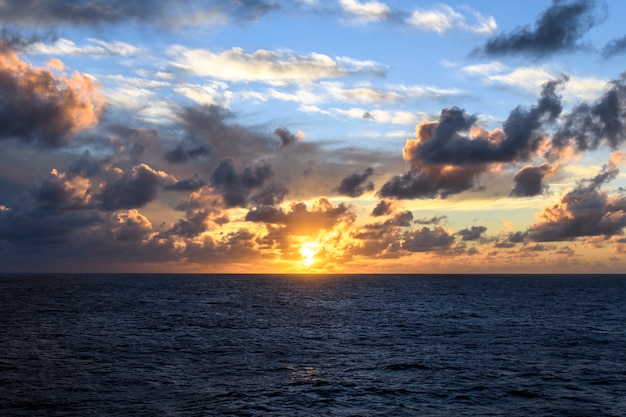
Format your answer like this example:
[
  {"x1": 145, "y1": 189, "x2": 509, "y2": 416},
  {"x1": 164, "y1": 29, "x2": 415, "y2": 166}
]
[{"x1": 0, "y1": 40, "x2": 104, "y2": 147}]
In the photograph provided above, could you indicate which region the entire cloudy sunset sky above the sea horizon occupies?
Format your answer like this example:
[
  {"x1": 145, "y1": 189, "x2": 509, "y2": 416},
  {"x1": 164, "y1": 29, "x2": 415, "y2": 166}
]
[{"x1": 0, "y1": 0, "x2": 626, "y2": 273}]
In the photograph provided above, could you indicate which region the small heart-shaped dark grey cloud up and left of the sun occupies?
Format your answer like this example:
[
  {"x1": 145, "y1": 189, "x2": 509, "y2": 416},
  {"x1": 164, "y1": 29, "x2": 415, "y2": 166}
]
[{"x1": 210, "y1": 158, "x2": 272, "y2": 207}]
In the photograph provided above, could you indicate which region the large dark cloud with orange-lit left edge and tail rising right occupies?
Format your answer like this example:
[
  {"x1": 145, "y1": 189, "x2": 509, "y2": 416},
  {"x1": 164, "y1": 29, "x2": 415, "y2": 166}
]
[{"x1": 378, "y1": 78, "x2": 565, "y2": 199}]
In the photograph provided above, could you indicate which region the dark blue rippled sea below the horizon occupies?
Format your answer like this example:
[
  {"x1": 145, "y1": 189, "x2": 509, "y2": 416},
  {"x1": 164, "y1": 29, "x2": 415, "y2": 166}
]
[{"x1": 0, "y1": 275, "x2": 626, "y2": 416}]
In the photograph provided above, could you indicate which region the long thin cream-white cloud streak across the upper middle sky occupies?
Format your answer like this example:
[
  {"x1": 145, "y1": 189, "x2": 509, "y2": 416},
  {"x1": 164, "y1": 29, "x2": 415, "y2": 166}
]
[{"x1": 168, "y1": 46, "x2": 386, "y2": 85}]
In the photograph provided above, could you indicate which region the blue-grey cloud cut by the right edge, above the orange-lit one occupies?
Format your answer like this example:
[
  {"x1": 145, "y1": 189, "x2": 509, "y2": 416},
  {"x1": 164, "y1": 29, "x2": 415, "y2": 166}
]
[{"x1": 548, "y1": 75, "x2": 626, "y2": 157}]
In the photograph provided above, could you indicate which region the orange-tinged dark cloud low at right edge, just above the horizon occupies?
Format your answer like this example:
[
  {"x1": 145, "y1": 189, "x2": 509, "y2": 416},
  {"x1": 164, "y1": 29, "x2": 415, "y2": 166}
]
[{"x1": 528, "y1": 162, "x2": 626, "y2": 242}]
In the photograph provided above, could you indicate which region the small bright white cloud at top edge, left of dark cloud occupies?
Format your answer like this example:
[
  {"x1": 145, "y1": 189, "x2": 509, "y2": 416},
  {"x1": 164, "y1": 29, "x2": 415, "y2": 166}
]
[{"x1": 406, "y1": 4, "x2": 497, "y2": 34}]
